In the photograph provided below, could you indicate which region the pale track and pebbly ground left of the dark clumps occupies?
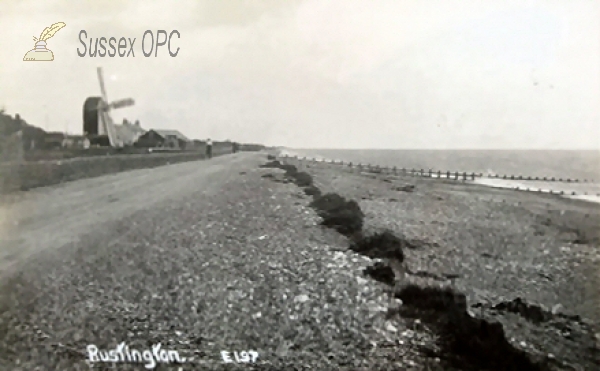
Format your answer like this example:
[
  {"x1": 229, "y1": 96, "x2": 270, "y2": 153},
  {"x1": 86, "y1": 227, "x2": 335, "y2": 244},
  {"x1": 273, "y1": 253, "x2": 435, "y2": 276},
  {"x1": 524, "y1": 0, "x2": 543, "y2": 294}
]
[{"x1": 0, "y1": 153, "x2": 402, "y2": 371}]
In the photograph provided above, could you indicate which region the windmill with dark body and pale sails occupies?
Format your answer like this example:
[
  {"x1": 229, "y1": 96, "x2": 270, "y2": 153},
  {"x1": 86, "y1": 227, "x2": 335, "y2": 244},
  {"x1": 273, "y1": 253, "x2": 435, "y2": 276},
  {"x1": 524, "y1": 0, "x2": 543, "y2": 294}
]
[{"x1": 83, "y1": 67, "x2": 135, "y2": 148}]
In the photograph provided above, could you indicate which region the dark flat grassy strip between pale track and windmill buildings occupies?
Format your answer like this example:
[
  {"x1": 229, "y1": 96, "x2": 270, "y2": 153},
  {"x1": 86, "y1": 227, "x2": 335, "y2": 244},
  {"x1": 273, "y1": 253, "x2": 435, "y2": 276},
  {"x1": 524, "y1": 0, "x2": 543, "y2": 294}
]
[{"x1": 0, "y1": 152, "x2": 211, "y2": 194}]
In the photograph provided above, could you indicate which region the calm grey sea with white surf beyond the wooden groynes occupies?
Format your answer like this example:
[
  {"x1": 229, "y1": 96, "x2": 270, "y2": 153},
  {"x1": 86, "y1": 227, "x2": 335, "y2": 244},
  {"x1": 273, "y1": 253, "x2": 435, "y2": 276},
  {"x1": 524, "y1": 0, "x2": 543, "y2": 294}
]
[{"x1": 283, "y1": 148, "x2": 600, "y2": 202}]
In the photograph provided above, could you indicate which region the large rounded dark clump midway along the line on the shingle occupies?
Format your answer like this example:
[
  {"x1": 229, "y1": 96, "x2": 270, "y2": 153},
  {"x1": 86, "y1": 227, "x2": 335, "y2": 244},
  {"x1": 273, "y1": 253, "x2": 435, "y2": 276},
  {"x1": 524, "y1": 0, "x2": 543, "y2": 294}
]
[{"x1": 310, "y1": 193, "x2": 365, "y2": 236}]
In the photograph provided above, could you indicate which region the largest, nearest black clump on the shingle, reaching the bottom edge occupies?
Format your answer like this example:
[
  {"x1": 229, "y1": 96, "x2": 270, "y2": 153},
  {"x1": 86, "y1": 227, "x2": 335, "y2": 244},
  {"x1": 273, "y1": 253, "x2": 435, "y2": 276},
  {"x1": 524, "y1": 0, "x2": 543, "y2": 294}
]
[{"x1": 395, "y1": 284, "x2": 550, "y2": 371}]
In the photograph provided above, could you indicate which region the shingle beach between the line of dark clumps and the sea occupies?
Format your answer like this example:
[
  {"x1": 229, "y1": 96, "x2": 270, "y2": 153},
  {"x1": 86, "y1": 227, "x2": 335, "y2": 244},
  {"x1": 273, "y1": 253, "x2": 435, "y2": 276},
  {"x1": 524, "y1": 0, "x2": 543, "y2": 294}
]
[{"x1": 270, "y1": 153, "x2": 600, "y2": 370}]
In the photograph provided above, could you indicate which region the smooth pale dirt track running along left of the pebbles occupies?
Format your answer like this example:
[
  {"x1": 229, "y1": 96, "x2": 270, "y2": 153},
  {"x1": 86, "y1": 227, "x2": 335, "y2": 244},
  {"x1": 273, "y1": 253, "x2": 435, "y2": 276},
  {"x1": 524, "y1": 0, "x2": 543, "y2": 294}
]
[{"x1": 0, "y1": 154, "x2": 249, "y2": 275}]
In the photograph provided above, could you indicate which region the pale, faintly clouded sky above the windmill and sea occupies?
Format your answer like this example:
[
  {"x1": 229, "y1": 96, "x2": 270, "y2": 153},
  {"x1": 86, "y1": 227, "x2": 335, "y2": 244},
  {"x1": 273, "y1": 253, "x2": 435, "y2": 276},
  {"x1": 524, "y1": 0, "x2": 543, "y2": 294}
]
[{"x1": 0, "y1": 0, "x2": 600, "y2": 149}]
